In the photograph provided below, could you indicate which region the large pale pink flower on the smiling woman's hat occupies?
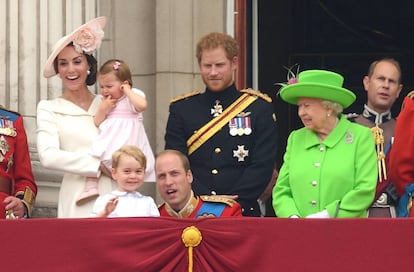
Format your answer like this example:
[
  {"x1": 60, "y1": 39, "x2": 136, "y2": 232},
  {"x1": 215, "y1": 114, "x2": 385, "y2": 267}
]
[{"x1": 73, "y1": 24, "x2": 104, "y2": 55}]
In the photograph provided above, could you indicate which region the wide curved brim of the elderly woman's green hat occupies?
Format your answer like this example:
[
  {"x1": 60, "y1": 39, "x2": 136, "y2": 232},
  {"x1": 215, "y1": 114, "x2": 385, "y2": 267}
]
[{"x1": 280, "y1": 83, "x2": 356, "y2": 108}]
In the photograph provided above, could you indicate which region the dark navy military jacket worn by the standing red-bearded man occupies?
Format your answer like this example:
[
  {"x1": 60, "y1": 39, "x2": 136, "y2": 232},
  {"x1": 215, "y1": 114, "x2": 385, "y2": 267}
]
[{"x1": 165, "y1": 85, "x2": 277, "y2": 216}]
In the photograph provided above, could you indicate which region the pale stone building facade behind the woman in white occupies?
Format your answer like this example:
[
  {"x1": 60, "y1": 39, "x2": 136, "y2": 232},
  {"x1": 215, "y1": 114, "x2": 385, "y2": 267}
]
[{"x1": 0, "y1": 0, "x2": 239, "y2": 217}]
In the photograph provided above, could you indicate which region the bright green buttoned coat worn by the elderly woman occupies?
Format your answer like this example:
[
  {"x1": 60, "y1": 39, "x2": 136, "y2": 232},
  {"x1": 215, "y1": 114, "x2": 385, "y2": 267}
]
[{"x1": 273, "y1": 116, "x2": 378, "y2": 218}]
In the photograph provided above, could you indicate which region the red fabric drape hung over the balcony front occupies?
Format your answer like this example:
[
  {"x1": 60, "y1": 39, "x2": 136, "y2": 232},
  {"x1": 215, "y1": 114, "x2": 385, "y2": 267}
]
[{"x1": 0, "y1": 217, "x2": 414, "y2": 272}]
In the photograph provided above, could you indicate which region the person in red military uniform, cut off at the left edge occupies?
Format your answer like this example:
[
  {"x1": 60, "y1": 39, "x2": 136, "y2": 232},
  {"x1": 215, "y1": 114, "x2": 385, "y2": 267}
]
[{"x1": 0, "y1": 107, "x2": 37, "y2": 219}]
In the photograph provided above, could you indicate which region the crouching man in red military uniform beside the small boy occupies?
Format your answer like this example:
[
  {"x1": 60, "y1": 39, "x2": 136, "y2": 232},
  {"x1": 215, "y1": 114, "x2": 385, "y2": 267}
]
[{"x1": 155, "y1": 150, "x2": 242, "y2": 218}]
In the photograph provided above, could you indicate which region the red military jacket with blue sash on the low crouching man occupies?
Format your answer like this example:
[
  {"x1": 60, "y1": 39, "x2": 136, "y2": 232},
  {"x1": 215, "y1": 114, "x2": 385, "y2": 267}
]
[{"x1": 158, "y1": 196, "x2": 242, "y2": 218}]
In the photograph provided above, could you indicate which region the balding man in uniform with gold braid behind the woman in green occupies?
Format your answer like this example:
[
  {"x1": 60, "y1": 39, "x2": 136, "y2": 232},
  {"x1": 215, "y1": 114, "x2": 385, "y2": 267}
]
[{"x1": 350, "y1": 58, "x2": 403, "y2": 217}]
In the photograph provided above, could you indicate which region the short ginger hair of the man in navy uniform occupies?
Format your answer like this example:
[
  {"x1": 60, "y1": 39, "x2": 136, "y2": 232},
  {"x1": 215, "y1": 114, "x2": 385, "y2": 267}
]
[{"x1": 196, "y1": 32, "x2": 239, "y2": 63}]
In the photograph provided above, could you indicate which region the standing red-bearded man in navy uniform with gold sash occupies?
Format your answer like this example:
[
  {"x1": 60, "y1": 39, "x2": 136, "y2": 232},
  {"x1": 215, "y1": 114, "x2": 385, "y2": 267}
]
[{"x1": 165, "y1": 33, "x2": 277, "y2": 216}]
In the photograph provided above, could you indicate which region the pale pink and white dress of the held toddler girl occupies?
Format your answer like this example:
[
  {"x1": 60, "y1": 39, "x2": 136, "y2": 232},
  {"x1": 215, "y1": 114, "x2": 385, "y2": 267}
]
[{"x1": 91, "y1": 88, "x2": 155, "y2": 181}]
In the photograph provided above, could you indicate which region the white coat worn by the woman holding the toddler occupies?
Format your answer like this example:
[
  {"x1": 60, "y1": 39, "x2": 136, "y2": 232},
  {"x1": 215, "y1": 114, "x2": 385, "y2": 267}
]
[{"x1": 37, "y1": 96, "x2": 116, "y2": 218}]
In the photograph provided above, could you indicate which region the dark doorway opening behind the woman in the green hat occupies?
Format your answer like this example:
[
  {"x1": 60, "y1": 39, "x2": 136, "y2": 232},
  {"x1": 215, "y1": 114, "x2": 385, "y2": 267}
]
[{"x1": 254, "y1": 0, "x2": 414, "y2": 166}]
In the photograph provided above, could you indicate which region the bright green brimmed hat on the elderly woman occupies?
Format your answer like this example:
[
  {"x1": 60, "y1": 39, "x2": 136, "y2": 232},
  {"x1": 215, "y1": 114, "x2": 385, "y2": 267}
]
[{"x1": 280, "y1": 70, "x2": 356, "y2": 108}]
